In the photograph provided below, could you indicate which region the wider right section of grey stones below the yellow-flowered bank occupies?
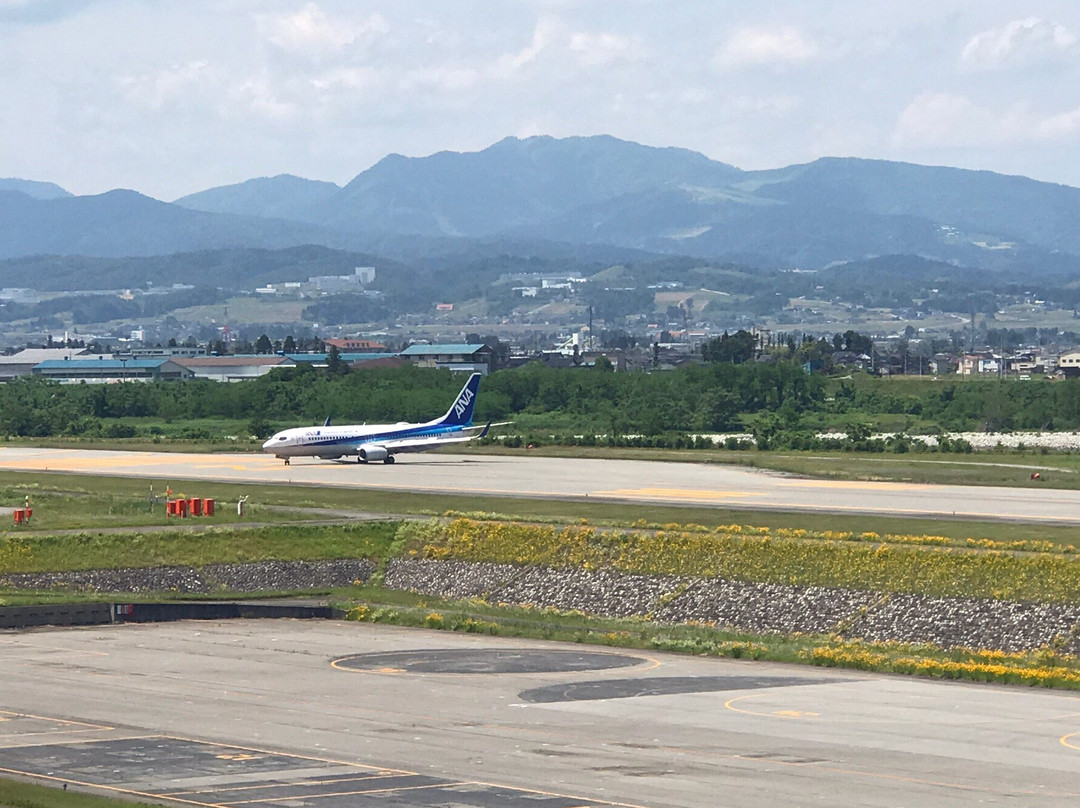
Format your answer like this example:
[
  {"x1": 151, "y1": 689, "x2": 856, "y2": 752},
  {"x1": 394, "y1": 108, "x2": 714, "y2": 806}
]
[{"x1": 386, "y1": 560, "x2": 1080, "y2": 654}]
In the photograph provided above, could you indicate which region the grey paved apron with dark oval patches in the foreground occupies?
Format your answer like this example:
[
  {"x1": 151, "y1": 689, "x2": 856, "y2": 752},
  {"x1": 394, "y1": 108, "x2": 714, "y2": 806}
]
[{"x1": 0, "y1": 620, "x2": 1080, "y2": 808}]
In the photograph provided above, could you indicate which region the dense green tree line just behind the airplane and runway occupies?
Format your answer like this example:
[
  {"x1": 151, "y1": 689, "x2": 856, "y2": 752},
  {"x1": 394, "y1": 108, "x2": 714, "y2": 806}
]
[{"x1": 0, "y1": 361, "x2": 1080, "y2": 436}]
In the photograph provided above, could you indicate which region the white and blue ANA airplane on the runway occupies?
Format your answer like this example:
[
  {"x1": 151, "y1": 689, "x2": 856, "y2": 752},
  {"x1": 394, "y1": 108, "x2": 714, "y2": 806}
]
[{"x1": 262, "y1": 373, "x2": 491, "y2": 466}]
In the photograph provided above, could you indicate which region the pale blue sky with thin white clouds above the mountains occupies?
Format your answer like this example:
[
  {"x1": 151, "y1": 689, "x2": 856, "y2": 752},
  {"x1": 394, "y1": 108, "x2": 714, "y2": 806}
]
[{"x1": 0, "y1": 0, "x2": 1080, "y2": 201}]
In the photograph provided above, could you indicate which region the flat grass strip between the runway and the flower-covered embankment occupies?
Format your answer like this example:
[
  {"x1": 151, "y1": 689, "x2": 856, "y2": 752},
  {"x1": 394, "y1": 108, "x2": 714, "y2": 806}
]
[{"x1": 6, "y1": 466, "x2": 1078, "y2": 544}]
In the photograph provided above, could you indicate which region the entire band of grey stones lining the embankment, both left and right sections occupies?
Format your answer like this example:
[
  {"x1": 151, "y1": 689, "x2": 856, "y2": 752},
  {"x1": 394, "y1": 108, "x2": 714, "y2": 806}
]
[{"x1": 10, "y1": 560, "x2": 1080, "y2": 654}]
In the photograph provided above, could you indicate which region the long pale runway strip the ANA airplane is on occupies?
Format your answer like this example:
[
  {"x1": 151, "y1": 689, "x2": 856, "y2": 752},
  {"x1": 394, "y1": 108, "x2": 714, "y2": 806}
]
[{"x1": 0, "y1": 448, "x2": 1080, "y2": 524}]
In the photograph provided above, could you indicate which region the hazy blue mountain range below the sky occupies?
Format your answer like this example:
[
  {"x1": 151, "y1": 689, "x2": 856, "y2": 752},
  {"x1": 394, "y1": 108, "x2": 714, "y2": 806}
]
[{"x1": 0, "y1": 136, "x2": 1080, "y2": 274}]
